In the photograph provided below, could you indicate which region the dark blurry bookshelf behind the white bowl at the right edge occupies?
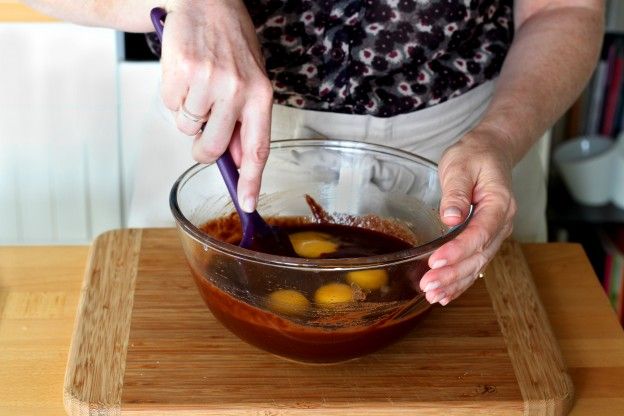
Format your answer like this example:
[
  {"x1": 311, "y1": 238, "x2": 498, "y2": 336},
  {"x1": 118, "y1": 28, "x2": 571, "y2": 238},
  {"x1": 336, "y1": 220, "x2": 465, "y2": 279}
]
[{"x1": 548, "y1": 4, "x2": 624, "y2": 325}]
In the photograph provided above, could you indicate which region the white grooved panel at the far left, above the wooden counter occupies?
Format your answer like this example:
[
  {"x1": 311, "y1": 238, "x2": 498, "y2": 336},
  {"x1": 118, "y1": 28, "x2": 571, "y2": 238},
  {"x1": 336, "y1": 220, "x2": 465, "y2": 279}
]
[{"x1": 0, "y1": 23, "x2": 123, "y2": 244}]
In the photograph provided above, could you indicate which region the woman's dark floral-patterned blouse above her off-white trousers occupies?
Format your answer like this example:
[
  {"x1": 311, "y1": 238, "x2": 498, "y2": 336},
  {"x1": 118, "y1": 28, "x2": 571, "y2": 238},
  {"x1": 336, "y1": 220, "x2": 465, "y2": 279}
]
[{"x1": 245, "y1": 0, "x2": 513, "y2": 117}]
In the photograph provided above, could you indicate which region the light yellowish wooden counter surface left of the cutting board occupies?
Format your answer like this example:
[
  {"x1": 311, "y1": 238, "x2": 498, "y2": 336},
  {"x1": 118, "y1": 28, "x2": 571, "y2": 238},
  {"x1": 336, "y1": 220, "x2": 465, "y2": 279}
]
[{"x1": 0, "y1": 246, "x2": 88, "y2": 416}]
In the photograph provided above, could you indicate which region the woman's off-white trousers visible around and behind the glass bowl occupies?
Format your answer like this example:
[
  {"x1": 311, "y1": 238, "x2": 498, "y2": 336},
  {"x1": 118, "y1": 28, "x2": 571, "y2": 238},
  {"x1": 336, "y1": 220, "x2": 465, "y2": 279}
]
[{"x1": 129, "y1": 82, "x2": 546, "y2": 241}]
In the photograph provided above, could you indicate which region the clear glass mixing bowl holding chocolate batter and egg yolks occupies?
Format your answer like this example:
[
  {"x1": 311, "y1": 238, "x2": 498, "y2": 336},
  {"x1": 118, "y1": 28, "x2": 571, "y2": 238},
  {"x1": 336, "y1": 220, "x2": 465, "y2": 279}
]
[{"x1": 170, "y1": 140, "x2": 470, "y2": 363}]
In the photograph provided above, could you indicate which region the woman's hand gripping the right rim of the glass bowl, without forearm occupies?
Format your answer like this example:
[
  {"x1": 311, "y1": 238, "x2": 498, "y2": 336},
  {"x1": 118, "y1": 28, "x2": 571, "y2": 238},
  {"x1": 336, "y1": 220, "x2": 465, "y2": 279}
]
[{"x1": 420, "y1": 126, "x2": 516, "y2": 306}]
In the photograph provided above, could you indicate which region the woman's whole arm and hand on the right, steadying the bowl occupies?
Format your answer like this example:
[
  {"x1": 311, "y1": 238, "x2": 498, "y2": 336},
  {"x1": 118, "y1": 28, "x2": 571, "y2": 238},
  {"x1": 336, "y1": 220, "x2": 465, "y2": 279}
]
[{"x1": 420, "y1": 0, "x2": 604, "y2": 305}]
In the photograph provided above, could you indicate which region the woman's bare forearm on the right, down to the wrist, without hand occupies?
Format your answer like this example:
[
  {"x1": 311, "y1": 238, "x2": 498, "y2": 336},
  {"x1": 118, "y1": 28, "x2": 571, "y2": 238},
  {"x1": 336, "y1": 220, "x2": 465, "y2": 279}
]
[{"x1": 480, "y1": 6, "x2": 603, "y2": 164}]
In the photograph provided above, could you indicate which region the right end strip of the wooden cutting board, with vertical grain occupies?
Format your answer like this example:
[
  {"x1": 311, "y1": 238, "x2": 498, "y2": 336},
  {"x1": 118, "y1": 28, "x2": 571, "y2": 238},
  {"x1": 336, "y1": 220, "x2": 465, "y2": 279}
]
[{"x1": 485, "y1": 239, "x2": 575, "y2": 416}]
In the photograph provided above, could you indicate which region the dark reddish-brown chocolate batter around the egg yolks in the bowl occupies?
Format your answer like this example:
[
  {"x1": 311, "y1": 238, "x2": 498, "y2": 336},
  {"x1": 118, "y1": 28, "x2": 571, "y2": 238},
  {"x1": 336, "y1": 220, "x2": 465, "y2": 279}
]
[{"x1": 191, "y1": 213, "x2": 429, "y2": 363}]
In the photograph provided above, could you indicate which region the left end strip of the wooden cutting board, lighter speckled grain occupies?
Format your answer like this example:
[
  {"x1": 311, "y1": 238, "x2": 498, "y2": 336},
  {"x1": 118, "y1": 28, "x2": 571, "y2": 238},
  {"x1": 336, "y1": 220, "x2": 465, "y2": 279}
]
[{"x1": 63, "y1": 230, "x2": 142, "y2": 415}]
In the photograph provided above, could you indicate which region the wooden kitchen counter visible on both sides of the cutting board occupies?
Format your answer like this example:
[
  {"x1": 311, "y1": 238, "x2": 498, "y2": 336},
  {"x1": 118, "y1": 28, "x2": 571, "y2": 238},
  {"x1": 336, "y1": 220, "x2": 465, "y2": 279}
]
[{"x1": 0, "y1": 239, "x2": 624, "y2": 416}]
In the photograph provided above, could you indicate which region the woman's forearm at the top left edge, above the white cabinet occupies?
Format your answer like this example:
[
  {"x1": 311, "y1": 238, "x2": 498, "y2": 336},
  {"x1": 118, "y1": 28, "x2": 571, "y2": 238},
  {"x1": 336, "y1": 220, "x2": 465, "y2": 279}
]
[{"x1": 25, "y1": 0, "x2": 166, "y2": 32}]
